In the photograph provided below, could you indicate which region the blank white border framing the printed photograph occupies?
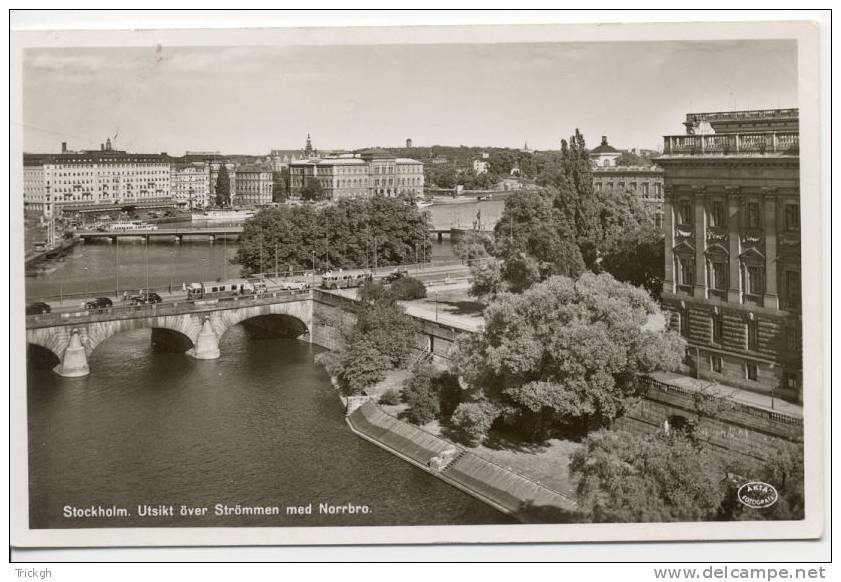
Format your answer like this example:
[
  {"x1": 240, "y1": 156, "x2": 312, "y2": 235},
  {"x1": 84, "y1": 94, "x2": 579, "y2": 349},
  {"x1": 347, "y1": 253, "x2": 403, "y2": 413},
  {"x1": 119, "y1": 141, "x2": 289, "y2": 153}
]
[{"x1": 9, "y1": 16, "x2": 824, "y2": 547}]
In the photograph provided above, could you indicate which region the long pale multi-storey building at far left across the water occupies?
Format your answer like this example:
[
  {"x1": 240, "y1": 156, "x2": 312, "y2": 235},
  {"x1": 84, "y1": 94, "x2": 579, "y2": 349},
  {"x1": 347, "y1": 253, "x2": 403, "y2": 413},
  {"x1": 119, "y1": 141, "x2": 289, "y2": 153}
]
[{"x1": 23, "y1": 140, "x2": 171, "y2": 217}]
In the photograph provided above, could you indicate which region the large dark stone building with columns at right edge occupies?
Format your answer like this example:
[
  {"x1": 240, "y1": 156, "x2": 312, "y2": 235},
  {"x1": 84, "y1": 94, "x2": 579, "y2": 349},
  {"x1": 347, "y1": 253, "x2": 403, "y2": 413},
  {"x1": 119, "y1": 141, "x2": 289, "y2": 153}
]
[{"x1": 657, "y1": 109, "x2": 802, "y2": 401}]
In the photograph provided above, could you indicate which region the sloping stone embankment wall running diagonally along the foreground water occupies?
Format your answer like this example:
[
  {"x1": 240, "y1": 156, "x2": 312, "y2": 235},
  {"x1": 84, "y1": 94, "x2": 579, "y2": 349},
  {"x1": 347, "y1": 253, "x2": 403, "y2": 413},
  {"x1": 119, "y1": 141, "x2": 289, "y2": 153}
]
[{"x1": 347, "y1": 400, "x2": 576, "y2": 523}]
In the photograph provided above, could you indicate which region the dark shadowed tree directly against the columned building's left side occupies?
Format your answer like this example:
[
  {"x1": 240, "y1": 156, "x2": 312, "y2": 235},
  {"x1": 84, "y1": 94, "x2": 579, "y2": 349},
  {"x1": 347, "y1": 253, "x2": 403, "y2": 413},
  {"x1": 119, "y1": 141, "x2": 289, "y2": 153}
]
[{"x1": 600, "y1": 224, "x2": 665, "y2": 299}]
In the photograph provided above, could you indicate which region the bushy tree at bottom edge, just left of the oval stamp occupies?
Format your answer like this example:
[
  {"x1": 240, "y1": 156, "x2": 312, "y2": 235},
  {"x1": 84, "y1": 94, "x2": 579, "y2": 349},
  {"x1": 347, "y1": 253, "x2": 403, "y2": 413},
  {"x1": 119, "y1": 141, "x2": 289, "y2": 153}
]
[{"x1": 569, "y1": 431, "x2": 728, "y2": 523}]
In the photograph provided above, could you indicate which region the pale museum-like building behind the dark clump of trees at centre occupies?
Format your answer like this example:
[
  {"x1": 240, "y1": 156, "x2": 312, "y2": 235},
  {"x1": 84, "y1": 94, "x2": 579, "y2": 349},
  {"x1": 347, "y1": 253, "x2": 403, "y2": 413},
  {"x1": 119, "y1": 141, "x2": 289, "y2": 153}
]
[{"x1": 289, "y1": 150, "x2": 423, "y2": 200}]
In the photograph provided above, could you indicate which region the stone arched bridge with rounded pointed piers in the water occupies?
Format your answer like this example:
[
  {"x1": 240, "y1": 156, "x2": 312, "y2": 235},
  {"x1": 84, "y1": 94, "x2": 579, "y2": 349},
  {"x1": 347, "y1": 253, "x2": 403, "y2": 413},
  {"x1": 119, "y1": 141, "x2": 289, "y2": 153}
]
[{"x1": 26, "y1": 291, "x2": 312, "y2": 378}]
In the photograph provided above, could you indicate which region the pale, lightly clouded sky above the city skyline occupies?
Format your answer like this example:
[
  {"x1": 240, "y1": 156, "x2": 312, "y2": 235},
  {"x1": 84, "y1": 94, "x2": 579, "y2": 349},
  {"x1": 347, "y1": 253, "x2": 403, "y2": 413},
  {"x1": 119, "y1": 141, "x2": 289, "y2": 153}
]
[{"x1": 18, "y1": 40, "x2": 797, "y2": 155}]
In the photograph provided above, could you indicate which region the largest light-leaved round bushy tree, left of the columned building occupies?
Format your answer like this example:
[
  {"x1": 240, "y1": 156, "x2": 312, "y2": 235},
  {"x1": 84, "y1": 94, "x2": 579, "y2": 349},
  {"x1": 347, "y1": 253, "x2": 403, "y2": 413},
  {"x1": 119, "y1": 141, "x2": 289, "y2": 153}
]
[{"x1": 456, "y1": 273, "x2": 685, "y2": 438}]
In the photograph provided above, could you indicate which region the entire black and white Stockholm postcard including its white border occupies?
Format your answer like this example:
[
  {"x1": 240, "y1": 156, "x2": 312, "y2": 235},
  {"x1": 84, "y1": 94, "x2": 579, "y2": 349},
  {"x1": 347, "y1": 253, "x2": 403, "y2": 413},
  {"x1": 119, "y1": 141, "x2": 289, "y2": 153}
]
[{"x1": 9, "y1": 12, "x2": 828, "y2": 547}]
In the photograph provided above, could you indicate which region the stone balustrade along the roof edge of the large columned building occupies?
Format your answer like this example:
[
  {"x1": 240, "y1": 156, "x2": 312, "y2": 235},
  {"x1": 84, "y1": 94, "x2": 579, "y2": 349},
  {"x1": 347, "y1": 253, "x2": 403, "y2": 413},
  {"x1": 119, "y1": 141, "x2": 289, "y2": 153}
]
[{"x1": 663, "y1": 132, "x2": 800, "y2": 157}]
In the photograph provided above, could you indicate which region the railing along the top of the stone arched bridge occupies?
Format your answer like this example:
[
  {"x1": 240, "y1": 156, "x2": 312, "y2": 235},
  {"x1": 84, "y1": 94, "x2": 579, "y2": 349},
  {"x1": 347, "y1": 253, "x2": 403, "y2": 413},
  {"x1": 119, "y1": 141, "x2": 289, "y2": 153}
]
[{"x1": 26, "y1": 290, "x2": 311, "y2": 328}]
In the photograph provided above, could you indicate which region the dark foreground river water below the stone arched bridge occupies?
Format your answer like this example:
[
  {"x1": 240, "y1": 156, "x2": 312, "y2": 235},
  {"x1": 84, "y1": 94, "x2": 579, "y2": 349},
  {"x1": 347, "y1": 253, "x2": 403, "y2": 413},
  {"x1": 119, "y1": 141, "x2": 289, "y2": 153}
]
[{"x1": 28, "y1": 334, "x2": 510, "y2": 528}]
